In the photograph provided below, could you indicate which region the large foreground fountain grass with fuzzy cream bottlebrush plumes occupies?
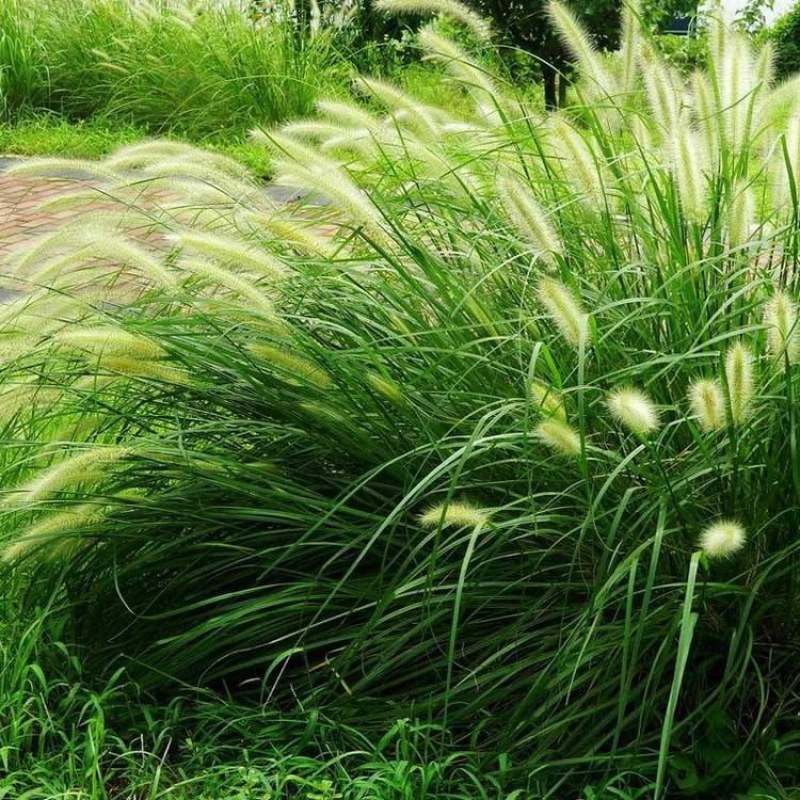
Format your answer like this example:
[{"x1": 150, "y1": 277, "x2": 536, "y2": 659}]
[{"x1": 0, "y1": 0, "x2": 800, "y2": 797}]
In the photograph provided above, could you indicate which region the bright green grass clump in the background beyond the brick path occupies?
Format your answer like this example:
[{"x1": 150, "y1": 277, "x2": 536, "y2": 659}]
[{"x1": 0, "y1": 0, "x2": 346, "y2": 137}]
